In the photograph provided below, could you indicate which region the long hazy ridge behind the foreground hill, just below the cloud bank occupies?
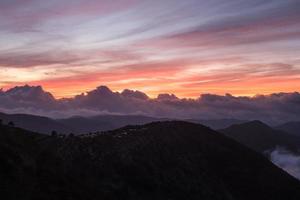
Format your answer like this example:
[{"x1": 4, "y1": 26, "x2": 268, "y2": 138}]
[{"x1": 0, "y1": 113, "x2": 253, "y2": 134}]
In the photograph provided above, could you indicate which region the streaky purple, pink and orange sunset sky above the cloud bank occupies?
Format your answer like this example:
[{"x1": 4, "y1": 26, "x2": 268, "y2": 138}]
[{"x1": 0, "y1": 0, "x2": 300, "y2": 98}]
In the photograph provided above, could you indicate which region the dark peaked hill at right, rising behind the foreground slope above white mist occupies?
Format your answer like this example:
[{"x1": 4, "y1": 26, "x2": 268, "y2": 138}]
[{"x1": 220, "y1": 121, "x2": 300, "y2": 152}]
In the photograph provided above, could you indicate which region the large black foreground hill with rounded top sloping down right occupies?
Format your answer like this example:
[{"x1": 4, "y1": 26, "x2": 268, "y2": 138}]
[{"x1": 0, "y1": 122, "x2": 300, "y2": 200}]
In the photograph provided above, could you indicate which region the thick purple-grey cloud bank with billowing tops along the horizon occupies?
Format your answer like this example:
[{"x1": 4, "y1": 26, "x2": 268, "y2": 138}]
[{"x1": 0, "y1": 85, "x2": 300, "y2": 124}]
